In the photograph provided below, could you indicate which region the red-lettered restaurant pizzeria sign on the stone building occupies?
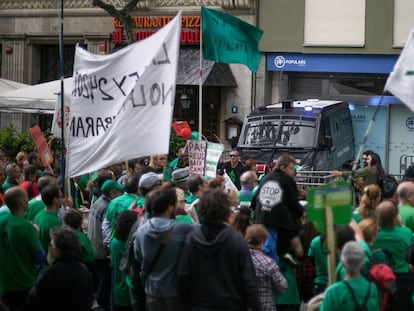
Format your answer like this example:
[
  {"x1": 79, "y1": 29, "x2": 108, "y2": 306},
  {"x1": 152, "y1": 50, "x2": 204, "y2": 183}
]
[{"x1": 112, "y1": 16, "x2": 200, "y2": 45}]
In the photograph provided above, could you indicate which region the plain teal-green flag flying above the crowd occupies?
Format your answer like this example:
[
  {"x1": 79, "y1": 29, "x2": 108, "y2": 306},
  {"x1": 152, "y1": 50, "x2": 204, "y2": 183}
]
[{"x1": 201, "y1": 6, "x2": 263, "y2": 72}]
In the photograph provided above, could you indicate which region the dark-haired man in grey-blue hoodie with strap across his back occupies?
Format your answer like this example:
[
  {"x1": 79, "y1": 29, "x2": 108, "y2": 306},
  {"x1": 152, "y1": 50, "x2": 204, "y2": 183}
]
[{"x1": 134, "y1": 188, "x2": 195, "y2": 311}]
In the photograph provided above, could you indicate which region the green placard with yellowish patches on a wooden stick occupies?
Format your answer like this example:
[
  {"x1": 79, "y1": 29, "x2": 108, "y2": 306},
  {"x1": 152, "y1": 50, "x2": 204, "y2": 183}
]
[{"x1": 307, "y1": 181, "x2": 352, "y2": 233}]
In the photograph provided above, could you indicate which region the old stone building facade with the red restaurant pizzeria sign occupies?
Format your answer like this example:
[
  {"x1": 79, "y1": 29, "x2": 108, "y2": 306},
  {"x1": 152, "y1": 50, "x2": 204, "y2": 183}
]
[{"x1": 0, "y1": 0, "x2": 256, "y2": 144}]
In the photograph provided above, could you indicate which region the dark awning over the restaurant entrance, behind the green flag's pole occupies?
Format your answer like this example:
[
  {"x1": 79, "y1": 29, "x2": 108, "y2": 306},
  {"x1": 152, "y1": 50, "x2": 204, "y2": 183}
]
[{"x1": 177, "y1": 47, "x2": 237, "y2": 87}]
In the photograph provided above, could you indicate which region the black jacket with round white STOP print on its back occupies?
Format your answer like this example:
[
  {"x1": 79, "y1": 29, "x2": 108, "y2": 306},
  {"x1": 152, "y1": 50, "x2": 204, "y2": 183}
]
[{"x1": 252, "y1": 169, "x2": 303, "y2": 231}]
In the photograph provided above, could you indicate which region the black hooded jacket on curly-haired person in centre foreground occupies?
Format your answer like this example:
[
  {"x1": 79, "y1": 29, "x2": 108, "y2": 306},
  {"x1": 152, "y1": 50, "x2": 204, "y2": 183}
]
[{"x1": 178, "y1": 224, "x2": 259, "y2": 311}]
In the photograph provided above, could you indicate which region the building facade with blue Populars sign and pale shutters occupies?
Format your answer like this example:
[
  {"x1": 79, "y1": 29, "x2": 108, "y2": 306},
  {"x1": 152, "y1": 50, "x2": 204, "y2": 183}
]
[{"x1": 256, "y1": 0, "x2": 414, "y2": 174}]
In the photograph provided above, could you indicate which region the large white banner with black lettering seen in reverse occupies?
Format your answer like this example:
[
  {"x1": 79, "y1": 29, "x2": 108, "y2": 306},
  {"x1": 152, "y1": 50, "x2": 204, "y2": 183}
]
[{"x1": 67, "y1": 12, "x2": 181, "y2": 177}]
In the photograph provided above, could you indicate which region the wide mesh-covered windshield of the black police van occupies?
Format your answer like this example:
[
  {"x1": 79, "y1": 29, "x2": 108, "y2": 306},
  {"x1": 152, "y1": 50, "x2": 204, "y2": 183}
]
[{"x1": 239, "y1": 120, "x2": 316, "y2": 148}]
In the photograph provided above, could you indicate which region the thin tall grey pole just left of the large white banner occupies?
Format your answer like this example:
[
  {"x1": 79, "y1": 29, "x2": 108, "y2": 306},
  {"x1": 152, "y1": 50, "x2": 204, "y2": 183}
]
[{"x1": 59, "y1": 0, "x2": 68, "y2": 197}]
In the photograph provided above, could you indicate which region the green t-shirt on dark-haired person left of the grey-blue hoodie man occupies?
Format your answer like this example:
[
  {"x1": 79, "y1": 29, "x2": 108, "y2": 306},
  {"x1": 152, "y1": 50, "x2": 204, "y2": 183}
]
[{"x1": 109, "y1": 237, "x2": 131, "y2": 306}]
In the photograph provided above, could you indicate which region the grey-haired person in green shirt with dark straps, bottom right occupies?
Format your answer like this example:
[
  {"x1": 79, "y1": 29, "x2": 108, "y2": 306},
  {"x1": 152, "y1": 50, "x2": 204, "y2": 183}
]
[{"x1": 319, "y1": 241, "x2": 380, "y2": 311}]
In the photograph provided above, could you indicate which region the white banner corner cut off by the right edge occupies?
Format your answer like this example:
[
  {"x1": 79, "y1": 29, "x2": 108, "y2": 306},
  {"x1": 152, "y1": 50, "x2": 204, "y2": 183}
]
[{"x1": 385, "y1": 28, "x2": 414, "y2": 111}]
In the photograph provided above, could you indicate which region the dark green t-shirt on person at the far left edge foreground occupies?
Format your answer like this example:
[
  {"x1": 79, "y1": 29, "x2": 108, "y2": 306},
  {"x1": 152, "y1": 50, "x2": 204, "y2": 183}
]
[{"x1": 0, "y1": 214, "x2": 43, "y2": 293}]
